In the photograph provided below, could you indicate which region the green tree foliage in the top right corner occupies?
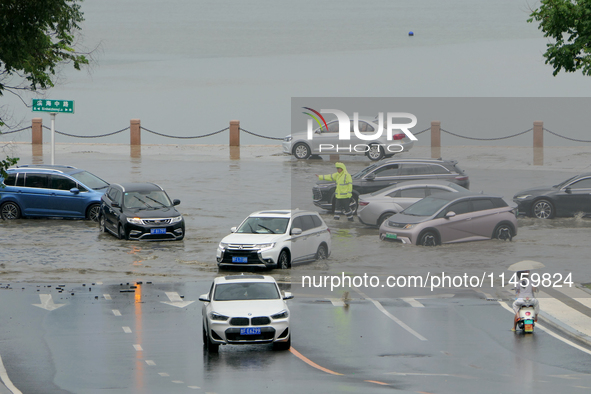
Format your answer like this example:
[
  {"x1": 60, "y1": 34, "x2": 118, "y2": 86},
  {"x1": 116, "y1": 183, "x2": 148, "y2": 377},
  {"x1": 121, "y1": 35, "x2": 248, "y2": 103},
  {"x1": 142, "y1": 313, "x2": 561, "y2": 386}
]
[{"x1": 527, "y1": 0, "x2": 591, "y2": 76}]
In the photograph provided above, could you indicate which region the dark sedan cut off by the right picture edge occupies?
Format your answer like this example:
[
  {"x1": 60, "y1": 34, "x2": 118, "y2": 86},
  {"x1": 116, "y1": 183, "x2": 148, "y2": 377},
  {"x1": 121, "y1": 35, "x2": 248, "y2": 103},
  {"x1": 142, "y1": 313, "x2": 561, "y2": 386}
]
[{"x1": 513, "y1": 173, "x2": 591, "y2": 219}]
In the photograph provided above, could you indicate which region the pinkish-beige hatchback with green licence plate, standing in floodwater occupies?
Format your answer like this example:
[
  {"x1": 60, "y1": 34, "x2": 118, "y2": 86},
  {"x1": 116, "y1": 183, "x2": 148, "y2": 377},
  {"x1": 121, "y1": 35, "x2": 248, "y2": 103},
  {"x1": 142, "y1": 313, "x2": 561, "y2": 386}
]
[{"x1": 380, "y1": 192, "x2": 517, "y2": 246}]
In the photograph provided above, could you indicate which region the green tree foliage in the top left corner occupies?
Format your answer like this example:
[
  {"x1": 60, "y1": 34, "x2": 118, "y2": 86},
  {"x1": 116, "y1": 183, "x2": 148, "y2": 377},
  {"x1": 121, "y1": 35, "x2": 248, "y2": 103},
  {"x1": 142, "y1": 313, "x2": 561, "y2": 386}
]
[{"x1": 0, "y1": 0, "x2": 89, "y2": 175}]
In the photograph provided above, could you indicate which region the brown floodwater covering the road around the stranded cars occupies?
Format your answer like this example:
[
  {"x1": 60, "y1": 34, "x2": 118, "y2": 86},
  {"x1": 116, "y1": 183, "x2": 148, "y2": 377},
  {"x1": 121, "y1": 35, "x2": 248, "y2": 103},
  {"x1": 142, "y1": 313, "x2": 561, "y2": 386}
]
[{"x1": 0, "y1": 144, "x2": 591, "y2": 291}]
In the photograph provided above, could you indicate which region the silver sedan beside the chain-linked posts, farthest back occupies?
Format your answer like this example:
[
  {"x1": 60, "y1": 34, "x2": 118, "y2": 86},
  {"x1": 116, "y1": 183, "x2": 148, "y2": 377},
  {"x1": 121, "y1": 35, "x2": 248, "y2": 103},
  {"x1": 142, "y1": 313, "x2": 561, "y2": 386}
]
[{"x1": 282, "y1": 117, "x2": 414, "y2": 160}]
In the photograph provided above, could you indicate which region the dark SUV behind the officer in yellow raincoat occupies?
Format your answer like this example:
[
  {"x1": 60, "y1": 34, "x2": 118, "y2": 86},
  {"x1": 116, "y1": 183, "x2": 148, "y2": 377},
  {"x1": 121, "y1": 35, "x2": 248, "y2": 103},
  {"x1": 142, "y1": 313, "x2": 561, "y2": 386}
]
[{"x1": 312, "y1": 159, "x2": 470, "y2": 212}]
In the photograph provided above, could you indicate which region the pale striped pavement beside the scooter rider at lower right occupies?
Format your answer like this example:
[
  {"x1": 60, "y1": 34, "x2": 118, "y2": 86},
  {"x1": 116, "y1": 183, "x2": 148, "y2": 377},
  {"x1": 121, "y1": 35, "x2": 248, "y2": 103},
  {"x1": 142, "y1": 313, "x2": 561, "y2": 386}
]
[{"x1": 503, "y1": 285, "x2": 591, "y2": 345}]
